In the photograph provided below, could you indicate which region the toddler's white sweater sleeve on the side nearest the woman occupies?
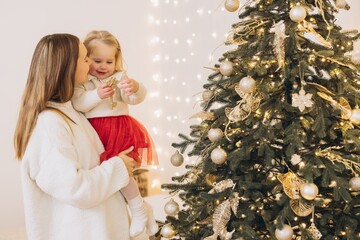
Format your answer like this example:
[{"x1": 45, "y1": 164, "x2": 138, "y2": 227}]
[{"x1": 71, "y1": 85, "x2": 102, "y2": 113}]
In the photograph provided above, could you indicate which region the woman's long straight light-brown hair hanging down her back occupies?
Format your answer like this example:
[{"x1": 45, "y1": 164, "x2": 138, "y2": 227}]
[{"x1": 14, "y1": 34, "x2": 80, "y2": 159}]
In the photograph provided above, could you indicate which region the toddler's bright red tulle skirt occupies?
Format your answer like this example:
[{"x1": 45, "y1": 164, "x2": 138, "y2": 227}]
[{"x1": 89, "y1": 115, "x2": 158, "y2": 165}]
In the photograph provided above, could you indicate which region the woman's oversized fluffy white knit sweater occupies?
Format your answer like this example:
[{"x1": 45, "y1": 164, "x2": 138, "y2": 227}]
[{"x1": 21, "y1": 102, "x2": 129, "y2": 240}]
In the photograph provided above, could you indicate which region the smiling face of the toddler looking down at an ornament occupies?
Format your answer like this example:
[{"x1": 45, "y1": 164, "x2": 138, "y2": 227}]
[{"x1": 89, "y1": 41, "x2": 116, "y2": 80}]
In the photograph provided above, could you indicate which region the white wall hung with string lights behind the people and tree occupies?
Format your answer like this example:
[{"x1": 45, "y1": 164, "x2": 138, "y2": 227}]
[{"x1": 0, "y1": 0, "x2": 360, "y2": 230}]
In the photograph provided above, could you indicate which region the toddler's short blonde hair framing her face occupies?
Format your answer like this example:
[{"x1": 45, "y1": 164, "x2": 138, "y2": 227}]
[{"x1": 84, "y1": 30, "x2": 124, "y2": 72}]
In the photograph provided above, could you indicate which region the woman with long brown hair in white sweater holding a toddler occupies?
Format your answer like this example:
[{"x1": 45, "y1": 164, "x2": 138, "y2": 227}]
[{"x1": 14, "y1": 34, "x2": 135, "y2": 240}]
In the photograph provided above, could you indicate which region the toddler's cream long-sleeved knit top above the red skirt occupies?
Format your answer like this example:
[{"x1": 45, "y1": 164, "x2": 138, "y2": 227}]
[{"x1": 71, "y1": 72, "x2": 146, "y2": 118}]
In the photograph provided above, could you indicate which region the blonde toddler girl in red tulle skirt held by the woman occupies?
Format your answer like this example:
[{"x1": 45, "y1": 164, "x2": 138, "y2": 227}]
[{"x1": 72, "y1": 31, "x2": 158, "y2": 237}]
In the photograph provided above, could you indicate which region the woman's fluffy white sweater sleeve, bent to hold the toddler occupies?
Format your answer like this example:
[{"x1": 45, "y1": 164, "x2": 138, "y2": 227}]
[{"x1": 33, "y1": 112, "x2": 129, "y2": 208}]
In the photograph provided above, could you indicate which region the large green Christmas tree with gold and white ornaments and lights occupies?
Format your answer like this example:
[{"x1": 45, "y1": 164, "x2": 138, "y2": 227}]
[{"x1": 161, "y1": 0, "x2": 360, "y2": 240}]
